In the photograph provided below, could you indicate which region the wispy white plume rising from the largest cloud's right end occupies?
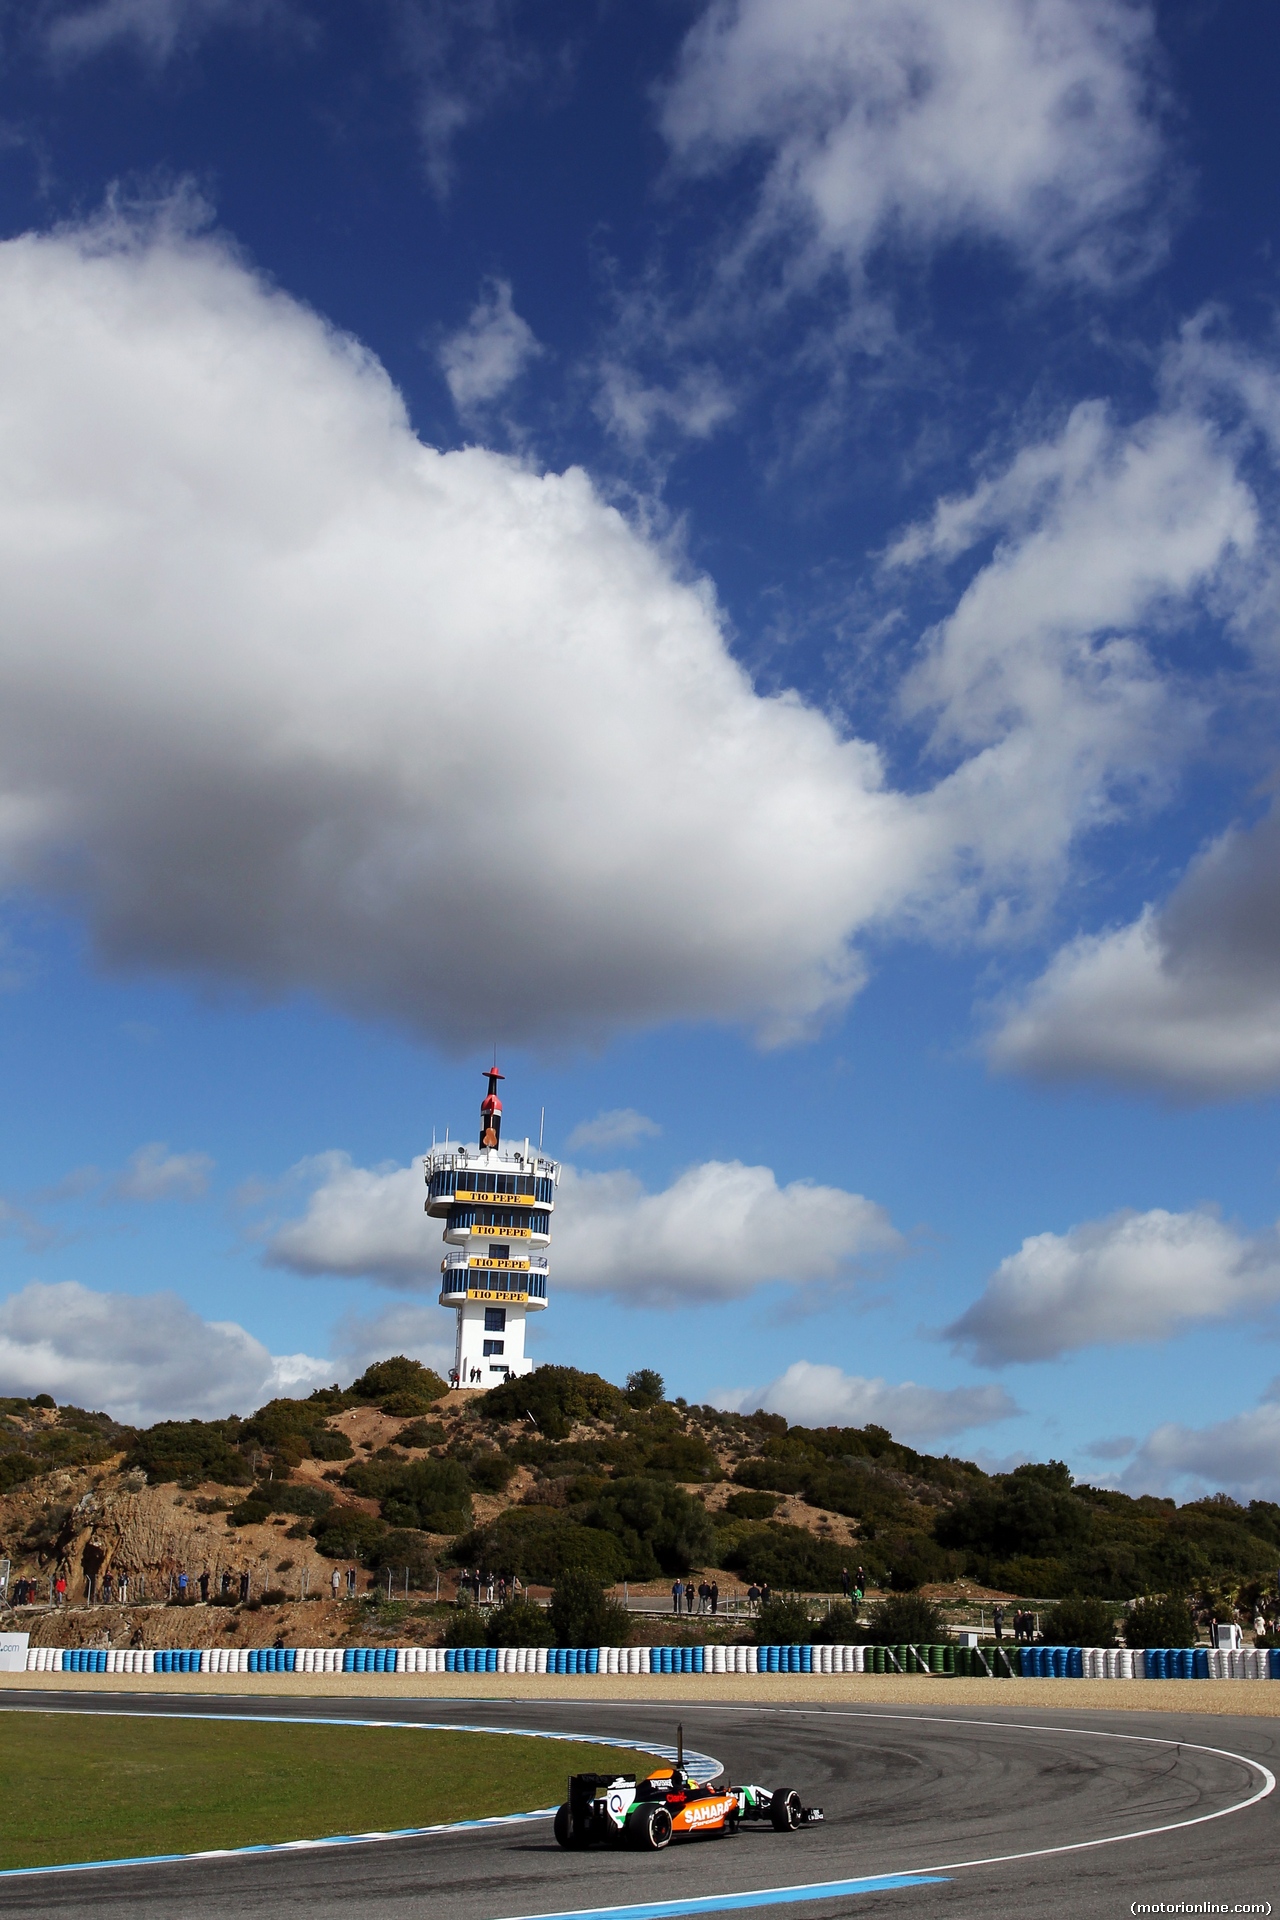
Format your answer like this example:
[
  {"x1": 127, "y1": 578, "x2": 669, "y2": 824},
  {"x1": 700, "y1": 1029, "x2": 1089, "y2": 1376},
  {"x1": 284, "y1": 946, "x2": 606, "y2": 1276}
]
[{"x1": 905, "y1": 401, "x2": 1257, "y2": 929}]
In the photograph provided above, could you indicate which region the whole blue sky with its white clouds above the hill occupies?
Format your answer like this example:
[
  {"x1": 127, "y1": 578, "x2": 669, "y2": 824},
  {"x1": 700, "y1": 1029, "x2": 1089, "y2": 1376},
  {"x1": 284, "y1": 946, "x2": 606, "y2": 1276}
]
[{"x1": 0, "y1": 0, "x2": 1280, "y2": 1498}]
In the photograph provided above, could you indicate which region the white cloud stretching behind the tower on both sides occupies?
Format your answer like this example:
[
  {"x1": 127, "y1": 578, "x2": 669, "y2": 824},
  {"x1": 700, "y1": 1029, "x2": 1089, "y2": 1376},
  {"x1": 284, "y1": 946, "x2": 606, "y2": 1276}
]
[{"x1": 267, "y1": 1154, "x2": 904, "y2": 1306}]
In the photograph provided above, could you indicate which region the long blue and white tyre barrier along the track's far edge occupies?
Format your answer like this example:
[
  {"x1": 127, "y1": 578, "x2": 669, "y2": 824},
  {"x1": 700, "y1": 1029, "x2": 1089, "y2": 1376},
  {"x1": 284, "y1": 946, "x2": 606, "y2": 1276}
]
[{"x1": 17, "y1": 1645, "x2": 1280, "y2": 1680}]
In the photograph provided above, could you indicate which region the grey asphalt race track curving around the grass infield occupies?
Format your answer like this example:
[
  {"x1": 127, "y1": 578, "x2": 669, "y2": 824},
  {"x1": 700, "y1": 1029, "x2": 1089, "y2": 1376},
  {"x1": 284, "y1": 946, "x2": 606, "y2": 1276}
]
[{"x1": 0, "y1": 1690, "x2": 1280, "y2": 1920}]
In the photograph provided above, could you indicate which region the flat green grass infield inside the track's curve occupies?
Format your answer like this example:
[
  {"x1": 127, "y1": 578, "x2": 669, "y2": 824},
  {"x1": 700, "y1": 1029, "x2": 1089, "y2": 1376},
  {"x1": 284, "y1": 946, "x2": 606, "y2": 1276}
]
[{"x1": 0, "y1": 1713, "x2": 652, "y2": 1866}]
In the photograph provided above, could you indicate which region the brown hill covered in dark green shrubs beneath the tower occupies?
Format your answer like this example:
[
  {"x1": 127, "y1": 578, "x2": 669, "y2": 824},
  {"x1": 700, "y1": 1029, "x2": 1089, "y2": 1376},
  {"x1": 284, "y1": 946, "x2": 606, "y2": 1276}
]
[{"x1": 0, "y1": 1356, "x2": 1280, "y2": 1644}]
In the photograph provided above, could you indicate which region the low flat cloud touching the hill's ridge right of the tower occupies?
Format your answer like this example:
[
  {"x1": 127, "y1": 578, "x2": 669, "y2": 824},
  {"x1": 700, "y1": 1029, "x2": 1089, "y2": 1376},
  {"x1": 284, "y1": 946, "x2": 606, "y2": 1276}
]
[{"x1": 712, "y1": 1359, "x2": 1021, "y2": 1446}]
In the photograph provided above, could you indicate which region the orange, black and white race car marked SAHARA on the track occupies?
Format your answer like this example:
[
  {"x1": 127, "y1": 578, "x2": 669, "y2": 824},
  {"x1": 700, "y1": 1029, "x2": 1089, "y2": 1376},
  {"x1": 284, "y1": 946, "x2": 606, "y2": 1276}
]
[{"x1": 555, "y1": 1766, "x2": 821, "y2": 1853}]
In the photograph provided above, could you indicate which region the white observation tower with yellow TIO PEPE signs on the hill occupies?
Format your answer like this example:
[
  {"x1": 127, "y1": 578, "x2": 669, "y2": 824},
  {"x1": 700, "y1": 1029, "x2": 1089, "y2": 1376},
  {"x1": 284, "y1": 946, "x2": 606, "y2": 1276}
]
[{"x1": 422, "y1": 1066, "x2": 560, "y2": 1386}]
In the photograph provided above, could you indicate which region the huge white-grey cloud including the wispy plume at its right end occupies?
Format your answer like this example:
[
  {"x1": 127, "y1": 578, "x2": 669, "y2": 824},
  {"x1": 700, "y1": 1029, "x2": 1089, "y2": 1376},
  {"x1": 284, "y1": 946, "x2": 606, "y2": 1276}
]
[{"x1": 0, "y1": 209, "x2": 1251, "y2": 1044}]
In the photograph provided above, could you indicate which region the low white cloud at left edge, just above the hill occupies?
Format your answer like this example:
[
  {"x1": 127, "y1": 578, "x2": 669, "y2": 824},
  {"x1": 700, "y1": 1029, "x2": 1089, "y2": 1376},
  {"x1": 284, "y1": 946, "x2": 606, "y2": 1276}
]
[{"x1": 0, "y1": 1281, "x2": 334, "y2": 1425}]
